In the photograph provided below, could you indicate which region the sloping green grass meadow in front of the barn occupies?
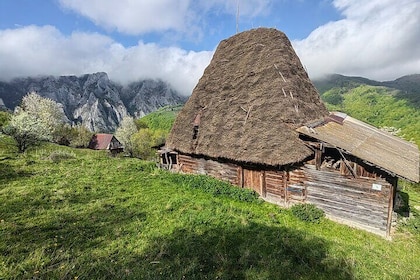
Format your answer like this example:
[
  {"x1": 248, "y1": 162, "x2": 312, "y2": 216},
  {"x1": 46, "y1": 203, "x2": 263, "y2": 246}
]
[{"x1": 0, "y1": 145, "x2": 420, "y2": 279}]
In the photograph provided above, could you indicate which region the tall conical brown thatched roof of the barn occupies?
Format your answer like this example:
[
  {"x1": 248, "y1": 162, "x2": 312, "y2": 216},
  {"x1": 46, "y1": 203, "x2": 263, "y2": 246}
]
[{"x1": 166, "y1": 28, "x2": 328, "y2": 166}]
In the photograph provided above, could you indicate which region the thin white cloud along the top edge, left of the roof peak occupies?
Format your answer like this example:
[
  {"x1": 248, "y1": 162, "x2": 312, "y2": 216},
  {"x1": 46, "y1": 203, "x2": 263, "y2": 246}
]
[{"x1": 59, "y1": 0, "x2": 272, "y2": 38}]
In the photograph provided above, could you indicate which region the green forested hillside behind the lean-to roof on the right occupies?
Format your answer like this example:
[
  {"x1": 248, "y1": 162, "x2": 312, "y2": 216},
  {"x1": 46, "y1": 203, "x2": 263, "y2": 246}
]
[{"x1": 314, "y1": 75, "x2": 420, "y2": 145}]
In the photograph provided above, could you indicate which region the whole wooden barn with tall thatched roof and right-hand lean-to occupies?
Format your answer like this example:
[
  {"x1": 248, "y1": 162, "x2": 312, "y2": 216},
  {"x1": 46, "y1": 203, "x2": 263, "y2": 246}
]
[{"x1": 161, "y1": 28, "x2": 419, "y2": 236}]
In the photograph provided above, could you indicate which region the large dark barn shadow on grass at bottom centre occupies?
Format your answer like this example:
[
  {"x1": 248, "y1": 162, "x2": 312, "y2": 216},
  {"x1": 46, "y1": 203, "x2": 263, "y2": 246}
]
[{"x1": 136, "y1": 224, "x2": 352, "y2": 279}]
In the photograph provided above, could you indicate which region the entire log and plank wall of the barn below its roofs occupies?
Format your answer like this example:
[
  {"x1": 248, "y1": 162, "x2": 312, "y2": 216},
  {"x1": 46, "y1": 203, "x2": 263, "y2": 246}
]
[{"x1": 173, "y1": 154, "x2": 394, "y2": 237}]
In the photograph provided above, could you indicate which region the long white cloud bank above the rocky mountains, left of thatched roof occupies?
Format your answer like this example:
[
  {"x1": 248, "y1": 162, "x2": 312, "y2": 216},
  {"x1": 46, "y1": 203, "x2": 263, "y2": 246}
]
[{"x1": 0, "y1": 26, "x2": 213, "y2": 95}]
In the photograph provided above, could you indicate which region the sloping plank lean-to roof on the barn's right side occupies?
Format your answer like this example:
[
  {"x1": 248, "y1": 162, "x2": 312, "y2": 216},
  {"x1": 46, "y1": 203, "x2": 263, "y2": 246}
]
[{"x1": 297, "y1": 112, "x2": 419, "y2": 182}]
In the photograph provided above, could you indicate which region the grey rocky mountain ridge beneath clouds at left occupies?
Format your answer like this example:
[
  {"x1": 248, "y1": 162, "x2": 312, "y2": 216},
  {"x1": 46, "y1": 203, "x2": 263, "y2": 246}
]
[{"x1": 0, "y1": 72, "x2": 187, "y2": 132}]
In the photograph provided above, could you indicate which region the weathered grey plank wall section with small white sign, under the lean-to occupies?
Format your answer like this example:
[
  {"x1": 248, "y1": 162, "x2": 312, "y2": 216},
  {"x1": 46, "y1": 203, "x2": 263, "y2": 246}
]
[{"x1": 304, "y1": 165, "x2": 393, "y2": 236}]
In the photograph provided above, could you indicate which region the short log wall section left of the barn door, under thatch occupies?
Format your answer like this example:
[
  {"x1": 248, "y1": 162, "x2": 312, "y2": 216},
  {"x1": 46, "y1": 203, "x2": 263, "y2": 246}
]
[{"x1": 178, "y1": 154, "x2": 240, "y2": 185}]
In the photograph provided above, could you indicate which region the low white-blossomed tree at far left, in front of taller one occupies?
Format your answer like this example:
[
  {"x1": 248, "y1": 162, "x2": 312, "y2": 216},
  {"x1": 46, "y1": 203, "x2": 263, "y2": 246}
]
[{"x1": 3, "y1": 109, "x2": 52, "y2": 153}]
